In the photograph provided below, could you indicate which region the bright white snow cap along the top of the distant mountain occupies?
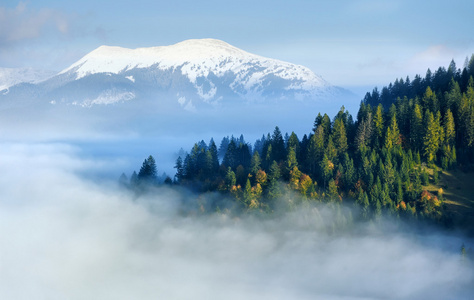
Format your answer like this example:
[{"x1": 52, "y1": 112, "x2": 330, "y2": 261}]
[{"x1": 60, "y1": 39, "x2": 328, "y2": 88}]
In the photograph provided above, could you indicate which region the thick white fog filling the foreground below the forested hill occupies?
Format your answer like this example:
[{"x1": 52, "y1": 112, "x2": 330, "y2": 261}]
[{"x1": 0, "y1": 143, "x2": 474, "y2": 300}]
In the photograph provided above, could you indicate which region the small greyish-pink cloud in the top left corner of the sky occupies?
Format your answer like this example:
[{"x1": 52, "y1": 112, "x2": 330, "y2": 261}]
[{"x1": 0, "y1": 2, "x2": 70, "y2": 47}]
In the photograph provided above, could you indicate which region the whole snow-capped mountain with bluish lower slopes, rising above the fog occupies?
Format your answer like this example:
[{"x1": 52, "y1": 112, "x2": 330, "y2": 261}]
[{"x1": 0, "y1": 39, "x2": 356, "y2": 110}]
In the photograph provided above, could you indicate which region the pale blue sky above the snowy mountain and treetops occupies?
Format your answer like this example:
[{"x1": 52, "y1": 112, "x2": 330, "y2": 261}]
[{"x1": 0, "y1": 0, "x2": 474, "y2": 88}]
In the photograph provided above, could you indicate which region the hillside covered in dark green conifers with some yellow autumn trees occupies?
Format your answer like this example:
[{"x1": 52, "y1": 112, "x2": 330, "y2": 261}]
[{"x1": 125, "y1": 55, "x2": 474, "y2": 230}]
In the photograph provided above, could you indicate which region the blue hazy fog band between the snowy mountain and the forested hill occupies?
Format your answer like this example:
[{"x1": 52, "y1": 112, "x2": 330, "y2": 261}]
[{"x1": 0, "y1": 101, "x2": 358, "y2": 178}]
